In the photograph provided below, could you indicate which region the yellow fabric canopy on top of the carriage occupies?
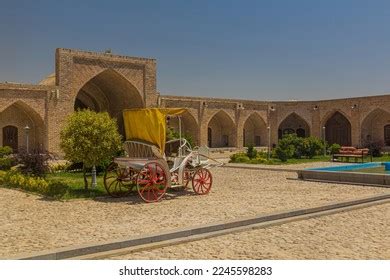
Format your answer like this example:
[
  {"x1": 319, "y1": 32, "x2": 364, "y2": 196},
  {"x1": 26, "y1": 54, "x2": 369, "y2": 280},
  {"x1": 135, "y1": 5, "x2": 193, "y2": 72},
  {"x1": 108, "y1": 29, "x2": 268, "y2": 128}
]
[{"x1": 123, "y1": 108, "x2": 186, "y2": 153}]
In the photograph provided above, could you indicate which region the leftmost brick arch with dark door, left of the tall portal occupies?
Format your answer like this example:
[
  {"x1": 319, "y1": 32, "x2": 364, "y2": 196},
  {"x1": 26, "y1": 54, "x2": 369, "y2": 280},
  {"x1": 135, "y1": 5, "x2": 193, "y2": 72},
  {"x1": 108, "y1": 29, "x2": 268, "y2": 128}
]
[{"x1": 0, "y1": 100, "x2": 46, "y2": 150}]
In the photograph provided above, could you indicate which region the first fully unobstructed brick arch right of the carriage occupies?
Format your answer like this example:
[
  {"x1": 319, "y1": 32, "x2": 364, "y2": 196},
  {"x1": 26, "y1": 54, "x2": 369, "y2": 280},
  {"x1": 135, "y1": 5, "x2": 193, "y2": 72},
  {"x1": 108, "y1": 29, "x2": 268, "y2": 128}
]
[{"x1": 207, "y1": 111, "x2": 236, "y2": 148}]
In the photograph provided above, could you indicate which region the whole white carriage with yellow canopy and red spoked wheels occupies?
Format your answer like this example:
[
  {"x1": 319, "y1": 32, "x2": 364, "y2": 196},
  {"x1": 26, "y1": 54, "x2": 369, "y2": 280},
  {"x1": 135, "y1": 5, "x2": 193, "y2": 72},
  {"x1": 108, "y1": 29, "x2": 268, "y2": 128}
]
[{"x1": 104, "y1": 108, "x2": 221, "y2": 202}]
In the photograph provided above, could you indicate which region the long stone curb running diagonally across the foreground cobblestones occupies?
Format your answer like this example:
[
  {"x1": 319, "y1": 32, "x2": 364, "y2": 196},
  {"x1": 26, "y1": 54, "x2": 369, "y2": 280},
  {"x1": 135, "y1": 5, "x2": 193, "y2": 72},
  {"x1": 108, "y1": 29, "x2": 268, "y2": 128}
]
[{"x1": 9, "y1": 193, "x2": 390, "y2": 260}]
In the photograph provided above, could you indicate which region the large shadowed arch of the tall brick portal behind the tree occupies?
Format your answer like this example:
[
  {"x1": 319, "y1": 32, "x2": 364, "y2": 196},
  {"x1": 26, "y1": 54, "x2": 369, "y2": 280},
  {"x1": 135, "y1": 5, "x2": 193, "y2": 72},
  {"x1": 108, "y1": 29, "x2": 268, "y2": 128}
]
[{"x1": 74, "y1": 69, "x2": 144, "y2": 135}]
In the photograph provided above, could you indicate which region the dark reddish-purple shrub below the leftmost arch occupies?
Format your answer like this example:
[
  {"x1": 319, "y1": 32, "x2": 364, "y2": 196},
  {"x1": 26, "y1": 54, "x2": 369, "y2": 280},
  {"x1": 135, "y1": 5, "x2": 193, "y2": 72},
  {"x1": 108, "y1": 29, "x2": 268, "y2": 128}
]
[{"x1": 17, "y1": 149, "x2": 51, "y2": 177}]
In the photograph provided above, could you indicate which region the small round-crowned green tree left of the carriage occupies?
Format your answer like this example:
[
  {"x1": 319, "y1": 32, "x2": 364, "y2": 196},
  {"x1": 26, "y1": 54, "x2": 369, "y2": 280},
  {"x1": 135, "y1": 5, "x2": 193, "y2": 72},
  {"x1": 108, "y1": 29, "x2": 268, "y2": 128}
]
[{"x1": 60, "y1": 110, "x2": 121, "y2": 189}]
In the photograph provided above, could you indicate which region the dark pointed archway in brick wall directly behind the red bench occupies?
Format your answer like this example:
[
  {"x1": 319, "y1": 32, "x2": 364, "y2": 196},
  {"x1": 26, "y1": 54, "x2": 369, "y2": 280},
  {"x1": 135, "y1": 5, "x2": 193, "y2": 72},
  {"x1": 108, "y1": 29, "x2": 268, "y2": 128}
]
[{"x1": 325, "y1": 111, "x2": 351, "y2": 146}]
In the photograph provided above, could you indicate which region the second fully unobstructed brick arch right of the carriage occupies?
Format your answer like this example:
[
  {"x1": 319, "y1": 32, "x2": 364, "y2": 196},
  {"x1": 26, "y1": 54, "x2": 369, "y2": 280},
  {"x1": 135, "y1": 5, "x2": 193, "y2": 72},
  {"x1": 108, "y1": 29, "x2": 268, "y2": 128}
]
[{"x1": 243, "y1": 113, "x2": 267, "y2": 147}]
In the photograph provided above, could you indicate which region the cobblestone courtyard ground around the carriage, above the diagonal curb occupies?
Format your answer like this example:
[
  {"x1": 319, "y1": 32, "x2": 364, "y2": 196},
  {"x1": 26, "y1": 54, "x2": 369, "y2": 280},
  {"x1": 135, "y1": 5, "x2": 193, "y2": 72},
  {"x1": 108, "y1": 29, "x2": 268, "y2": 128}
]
[{"x1": 0, "y1": 164, "x2": 389, "y2": 258}]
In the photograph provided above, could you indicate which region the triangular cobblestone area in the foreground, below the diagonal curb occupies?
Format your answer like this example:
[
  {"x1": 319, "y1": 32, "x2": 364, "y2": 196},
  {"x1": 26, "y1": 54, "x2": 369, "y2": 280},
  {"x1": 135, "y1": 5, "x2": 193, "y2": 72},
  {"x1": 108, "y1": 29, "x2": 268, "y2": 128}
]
[{"x1": 111, "y1": 203, "x2": 390, "y2": 260}]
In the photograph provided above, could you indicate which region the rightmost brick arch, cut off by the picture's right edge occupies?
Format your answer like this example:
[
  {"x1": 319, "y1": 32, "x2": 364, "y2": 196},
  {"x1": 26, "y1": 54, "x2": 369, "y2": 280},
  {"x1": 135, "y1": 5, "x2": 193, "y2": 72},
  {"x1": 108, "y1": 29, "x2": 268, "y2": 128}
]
[{"x1": 361, "y1": 108, "x2": 390, "y2": 146}]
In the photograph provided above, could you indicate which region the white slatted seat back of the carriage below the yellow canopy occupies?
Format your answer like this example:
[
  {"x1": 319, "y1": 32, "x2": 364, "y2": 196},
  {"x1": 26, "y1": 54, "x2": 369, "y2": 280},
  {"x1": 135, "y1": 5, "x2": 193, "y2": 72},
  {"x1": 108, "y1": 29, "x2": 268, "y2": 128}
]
[{"x1": 123, "y1": 139, "x2": 164, "y2": 159}]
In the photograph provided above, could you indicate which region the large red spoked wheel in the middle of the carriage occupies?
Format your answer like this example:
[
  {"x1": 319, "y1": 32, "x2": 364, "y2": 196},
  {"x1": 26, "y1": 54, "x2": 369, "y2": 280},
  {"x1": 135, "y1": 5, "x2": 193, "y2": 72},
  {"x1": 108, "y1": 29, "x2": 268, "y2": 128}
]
[{"x1": 137, "y1": 162, "x2": 168, "y2": 202}]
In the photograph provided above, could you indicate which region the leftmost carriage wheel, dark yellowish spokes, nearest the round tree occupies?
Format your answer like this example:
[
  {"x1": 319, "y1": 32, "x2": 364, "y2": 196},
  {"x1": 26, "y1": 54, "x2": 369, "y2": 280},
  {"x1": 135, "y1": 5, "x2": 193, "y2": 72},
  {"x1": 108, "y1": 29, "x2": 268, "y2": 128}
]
[{"x1": 104, "y1": 162, "x2": 134, "y2": 197}]
